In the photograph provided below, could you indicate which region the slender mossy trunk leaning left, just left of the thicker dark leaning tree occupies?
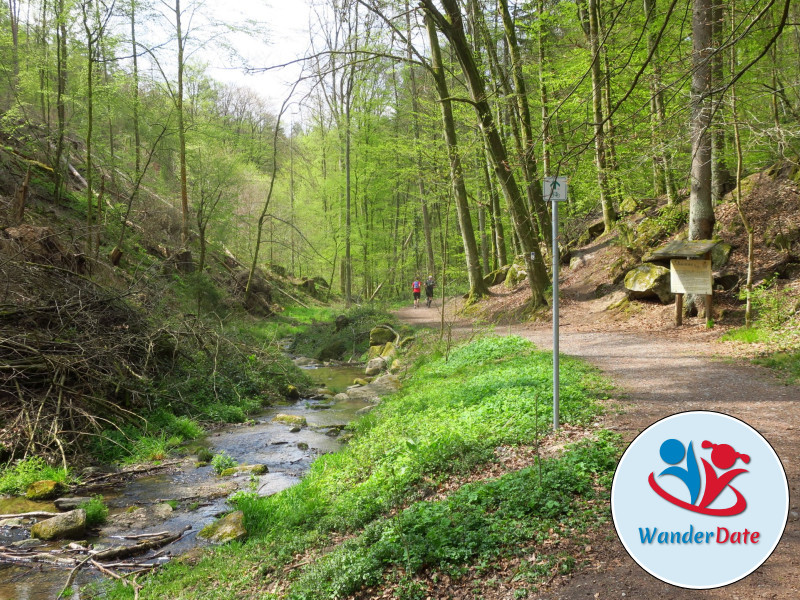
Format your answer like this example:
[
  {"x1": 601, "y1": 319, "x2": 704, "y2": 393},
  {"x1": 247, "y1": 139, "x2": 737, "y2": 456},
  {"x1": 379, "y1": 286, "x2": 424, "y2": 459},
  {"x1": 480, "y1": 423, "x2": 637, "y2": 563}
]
[{"x1": 425, "y1": 15, "x2": 489, "y2": 302}]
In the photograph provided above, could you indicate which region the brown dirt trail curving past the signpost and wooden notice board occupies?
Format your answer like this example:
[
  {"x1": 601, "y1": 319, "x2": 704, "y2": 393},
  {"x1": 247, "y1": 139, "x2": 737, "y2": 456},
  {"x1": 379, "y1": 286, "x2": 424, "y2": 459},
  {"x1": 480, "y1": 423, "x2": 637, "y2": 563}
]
[{"x1": 397, "y1": 302, "x2": 800, "y2": 600}]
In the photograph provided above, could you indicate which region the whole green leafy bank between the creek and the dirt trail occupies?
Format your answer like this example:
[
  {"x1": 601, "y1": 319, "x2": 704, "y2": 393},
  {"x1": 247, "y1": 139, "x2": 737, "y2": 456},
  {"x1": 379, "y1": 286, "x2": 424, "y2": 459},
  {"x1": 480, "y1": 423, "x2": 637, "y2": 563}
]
[{"x1": 106, "y1": 337, "x2": 617, "y2": 599}]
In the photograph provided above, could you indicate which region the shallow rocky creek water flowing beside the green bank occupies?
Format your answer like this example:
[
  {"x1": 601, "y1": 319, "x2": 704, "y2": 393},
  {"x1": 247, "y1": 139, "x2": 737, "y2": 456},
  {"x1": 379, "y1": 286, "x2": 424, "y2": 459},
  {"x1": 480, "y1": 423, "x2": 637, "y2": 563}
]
[{"x1": 0, "y1": 366, "x2": 370, "y2": 600}]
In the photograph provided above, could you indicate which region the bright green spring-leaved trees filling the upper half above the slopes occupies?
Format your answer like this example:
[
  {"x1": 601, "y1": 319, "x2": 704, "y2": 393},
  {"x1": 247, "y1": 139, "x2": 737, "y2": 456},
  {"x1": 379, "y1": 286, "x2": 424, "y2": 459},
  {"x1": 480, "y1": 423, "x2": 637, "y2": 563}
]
[{"x1": 2, "y1": 0, "x2": 800, "y2": 303}]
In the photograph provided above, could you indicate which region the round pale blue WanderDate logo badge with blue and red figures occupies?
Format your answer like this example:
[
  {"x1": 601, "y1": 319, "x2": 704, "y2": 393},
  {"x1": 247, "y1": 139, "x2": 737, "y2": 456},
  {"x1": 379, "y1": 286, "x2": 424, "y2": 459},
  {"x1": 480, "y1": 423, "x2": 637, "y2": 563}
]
[{"x1": 611, "y1": 411, "x2": 789, "y2": 589}]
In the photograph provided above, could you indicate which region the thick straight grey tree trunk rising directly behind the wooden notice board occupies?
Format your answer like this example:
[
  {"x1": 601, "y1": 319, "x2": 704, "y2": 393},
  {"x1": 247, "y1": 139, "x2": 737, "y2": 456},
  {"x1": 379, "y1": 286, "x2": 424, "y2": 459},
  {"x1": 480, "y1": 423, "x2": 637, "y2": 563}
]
[{"x1": 689, "y1": 0, "x2": 714, "y2": 240}]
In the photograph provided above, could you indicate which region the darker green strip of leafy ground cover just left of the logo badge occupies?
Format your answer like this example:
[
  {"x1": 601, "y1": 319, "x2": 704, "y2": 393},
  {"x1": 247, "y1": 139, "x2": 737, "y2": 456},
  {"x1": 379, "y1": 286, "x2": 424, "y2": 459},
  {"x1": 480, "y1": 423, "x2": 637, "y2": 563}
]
[{"x1": 288, "y1": 435, "x2": 618, "y2": 600}]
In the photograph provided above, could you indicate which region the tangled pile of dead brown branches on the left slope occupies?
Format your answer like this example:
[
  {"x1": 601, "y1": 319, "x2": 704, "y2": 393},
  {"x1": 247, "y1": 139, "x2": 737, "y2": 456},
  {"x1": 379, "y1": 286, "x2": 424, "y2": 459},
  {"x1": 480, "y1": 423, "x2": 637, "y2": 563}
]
[{"x1": 0, "y1": 254, "x2": 175, "y2": 462}]
